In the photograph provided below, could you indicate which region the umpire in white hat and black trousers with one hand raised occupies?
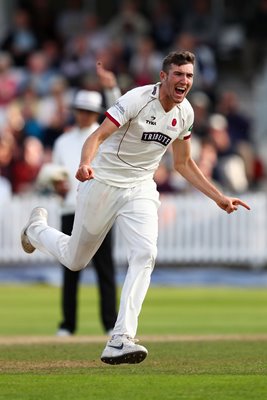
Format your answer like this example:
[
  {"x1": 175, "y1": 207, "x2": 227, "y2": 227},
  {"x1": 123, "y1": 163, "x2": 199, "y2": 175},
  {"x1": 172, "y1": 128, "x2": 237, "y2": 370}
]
[{"x1": 52, "y1": 63, "x2": 118, "y2": 336}]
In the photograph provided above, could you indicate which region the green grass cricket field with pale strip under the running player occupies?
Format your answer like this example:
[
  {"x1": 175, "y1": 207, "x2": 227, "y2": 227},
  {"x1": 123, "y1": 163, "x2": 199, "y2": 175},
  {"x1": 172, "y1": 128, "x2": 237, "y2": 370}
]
[{"x1": 0, "y1": 285, "x2": 267, "y2": 400}]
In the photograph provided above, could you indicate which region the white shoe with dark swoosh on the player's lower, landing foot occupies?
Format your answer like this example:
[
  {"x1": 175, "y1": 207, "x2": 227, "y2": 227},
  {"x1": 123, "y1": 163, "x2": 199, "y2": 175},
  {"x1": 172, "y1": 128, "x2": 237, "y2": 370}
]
[{"x1": 101, "y1": 335, "x2": 148, "y2": 365}]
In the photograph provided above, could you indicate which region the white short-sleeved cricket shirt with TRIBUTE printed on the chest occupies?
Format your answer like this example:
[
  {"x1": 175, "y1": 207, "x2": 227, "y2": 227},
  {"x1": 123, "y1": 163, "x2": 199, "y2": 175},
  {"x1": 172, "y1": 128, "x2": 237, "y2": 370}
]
[{"x1": 92, "y1": 83, "x2": 194, "y2": 188}]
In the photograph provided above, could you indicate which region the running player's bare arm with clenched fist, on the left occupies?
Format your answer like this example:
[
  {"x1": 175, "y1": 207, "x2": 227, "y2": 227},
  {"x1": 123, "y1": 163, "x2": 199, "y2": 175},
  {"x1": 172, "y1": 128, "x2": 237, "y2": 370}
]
[{"x1": 75, "y1": 118, "x2": 118, "y2": 182}]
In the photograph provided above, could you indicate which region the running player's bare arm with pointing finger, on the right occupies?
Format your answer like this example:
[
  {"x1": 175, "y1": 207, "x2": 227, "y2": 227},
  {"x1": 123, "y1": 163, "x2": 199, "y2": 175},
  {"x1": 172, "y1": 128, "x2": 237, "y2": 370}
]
[{"x1": 173, "y1": 139, "x2": 250, "y2": 214}]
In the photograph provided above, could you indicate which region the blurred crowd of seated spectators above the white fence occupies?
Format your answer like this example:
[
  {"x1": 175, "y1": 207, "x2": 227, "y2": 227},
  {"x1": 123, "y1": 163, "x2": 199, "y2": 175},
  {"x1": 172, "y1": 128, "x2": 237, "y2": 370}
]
[{"x1": 0, "y1": 0, "x2": 267, "y2": 202}]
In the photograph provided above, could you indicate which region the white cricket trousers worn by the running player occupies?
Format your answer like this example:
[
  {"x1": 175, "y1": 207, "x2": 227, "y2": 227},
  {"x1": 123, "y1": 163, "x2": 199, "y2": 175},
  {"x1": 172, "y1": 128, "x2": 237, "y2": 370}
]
[{"x1": 27, "y1": 179, "x2": 160, "y2": 338}]
